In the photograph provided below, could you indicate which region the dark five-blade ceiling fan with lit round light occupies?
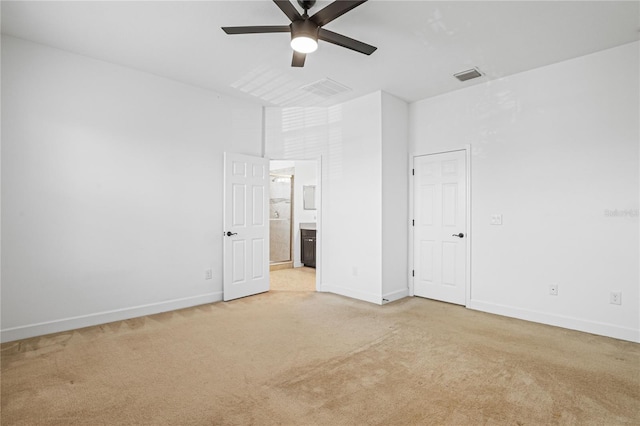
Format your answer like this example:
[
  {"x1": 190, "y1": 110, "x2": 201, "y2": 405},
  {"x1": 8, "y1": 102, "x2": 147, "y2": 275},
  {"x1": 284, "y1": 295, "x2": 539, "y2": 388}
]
[{"x1": 222, "y1": 0, "x2": 377, "y2": 67}]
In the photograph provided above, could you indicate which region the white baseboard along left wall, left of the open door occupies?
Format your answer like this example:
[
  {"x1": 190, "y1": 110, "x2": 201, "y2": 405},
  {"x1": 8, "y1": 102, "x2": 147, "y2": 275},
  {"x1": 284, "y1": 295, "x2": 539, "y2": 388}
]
[{"x1": 0, "y1": 291, "x2": 222, "y2": 343}]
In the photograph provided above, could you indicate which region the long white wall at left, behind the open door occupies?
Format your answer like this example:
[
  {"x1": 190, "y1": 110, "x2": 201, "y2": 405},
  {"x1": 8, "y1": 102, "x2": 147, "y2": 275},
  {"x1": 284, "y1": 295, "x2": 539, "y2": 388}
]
[{"x1": 2, "y1": 36, "x2": 262, "y2": 340}]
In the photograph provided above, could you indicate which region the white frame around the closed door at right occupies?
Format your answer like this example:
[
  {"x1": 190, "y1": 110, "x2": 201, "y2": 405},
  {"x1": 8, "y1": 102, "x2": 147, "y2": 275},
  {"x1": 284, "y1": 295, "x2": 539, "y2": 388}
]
[{"x1": 408, "y1": 145, "x2": 473, "y2": 306}]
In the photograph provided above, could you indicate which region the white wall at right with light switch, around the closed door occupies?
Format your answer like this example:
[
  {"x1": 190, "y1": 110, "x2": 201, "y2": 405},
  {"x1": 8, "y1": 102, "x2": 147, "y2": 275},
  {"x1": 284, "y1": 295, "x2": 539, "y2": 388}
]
[{"x1": 410, "y1": 43, "x2": 640, "y2": 341}]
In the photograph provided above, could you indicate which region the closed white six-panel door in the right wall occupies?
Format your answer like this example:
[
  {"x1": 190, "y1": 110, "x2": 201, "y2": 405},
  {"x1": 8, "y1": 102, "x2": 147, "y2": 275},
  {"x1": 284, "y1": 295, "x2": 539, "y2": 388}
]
[{"x1": 413, "y1": 151, "x2": 467, "y2": 305}]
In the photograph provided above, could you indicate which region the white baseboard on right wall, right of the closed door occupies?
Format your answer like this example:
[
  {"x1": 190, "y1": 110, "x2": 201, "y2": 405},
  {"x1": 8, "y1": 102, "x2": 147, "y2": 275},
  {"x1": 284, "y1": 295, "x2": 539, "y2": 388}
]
[{"x1": 467, "y1": 300, "x2": 640, "y2": 343}]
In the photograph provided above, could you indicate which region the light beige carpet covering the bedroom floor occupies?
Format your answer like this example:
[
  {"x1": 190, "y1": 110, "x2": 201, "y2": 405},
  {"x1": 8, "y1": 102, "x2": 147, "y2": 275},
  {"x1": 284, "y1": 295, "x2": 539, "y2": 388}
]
[{"x1": 1, "y1": 291, "x2": 640, "y2": 425}]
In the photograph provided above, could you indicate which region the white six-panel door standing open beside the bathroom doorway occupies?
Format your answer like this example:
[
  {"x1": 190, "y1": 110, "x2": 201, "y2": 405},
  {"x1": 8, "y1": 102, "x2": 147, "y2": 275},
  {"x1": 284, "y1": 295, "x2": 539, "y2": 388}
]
[{"x1": 223, "y1": 152, "x2": 269, "y2": 301}]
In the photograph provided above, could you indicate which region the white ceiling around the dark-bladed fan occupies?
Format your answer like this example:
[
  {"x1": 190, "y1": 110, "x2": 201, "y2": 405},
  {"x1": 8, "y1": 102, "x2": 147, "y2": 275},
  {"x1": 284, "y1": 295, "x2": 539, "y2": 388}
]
[{"x1": 2, "y1": 0, "x2": 640, "y2": 106}]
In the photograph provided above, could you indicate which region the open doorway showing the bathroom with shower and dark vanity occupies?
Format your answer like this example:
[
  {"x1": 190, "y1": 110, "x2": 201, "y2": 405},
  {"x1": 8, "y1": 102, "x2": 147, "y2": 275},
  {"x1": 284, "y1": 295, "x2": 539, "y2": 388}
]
[{"x1": 269, "y1": 160, "x2": 320, "y2": 291}]
